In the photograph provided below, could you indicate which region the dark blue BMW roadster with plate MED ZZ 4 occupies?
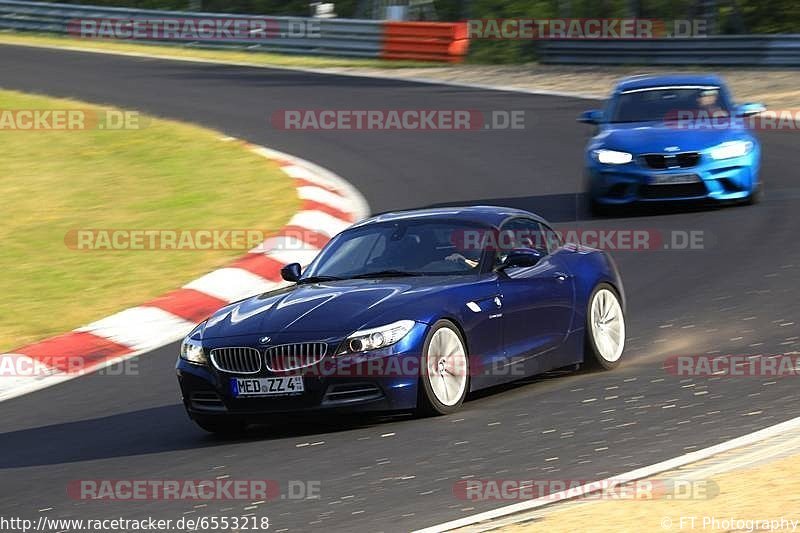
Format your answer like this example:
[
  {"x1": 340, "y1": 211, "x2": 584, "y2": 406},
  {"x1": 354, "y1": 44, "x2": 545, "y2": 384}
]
[{"x1": 177, "y1": 207, "x2": 625, "y2": 433}]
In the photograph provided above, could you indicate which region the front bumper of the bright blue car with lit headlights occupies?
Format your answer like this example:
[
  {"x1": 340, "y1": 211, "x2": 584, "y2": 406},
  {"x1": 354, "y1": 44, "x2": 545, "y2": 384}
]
[{"x1": 587, "y1": 153, "x2": 758, "y2": 206}]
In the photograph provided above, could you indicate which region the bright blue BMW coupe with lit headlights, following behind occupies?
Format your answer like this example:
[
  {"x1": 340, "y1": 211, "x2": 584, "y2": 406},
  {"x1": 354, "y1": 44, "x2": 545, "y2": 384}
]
[{"x1": 578, "y1": 75, "x2": 765, "y2": 213}]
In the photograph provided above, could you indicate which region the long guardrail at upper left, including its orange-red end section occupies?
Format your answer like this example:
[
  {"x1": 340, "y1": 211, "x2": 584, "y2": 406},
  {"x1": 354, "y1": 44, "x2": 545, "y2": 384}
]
[{"x1": 0, "y1": 0, "x2": 466, "y2": 61}]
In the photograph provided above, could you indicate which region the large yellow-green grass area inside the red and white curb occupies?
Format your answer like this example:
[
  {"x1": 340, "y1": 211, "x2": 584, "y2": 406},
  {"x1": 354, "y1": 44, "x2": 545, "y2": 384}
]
[{"x1": 0, "y1": 91, "x2": 299, "y2": 352}]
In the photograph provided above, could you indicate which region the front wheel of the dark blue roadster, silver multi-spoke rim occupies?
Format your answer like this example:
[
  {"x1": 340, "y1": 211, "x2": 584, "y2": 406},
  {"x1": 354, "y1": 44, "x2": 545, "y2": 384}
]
[{"x1": 419, "y1": 320, "x2": 469, "y2": 415}]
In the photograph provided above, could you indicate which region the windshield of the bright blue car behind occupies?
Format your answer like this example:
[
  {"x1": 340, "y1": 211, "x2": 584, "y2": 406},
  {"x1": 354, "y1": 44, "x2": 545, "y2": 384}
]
[{"x1": 609, "y1": 87, "x2": 730, "y2": 123}]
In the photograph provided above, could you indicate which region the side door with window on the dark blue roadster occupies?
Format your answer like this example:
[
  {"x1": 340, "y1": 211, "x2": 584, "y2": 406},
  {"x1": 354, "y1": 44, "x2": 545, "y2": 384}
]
[{"x1": 498, "y1": 218, "x2": 574, "y2": 375}]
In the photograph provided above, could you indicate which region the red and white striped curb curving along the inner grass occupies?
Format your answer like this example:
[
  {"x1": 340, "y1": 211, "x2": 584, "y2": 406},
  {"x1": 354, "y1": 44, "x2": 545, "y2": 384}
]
[{"x1": 0, "y1": 140, "x2": 369, "y2": 401}]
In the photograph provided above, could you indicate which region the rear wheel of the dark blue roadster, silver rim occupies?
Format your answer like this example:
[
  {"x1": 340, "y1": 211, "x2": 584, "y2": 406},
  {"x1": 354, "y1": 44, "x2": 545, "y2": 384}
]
[{"x1": 584, "y1": 283, "x2": 625, "y2": 370}]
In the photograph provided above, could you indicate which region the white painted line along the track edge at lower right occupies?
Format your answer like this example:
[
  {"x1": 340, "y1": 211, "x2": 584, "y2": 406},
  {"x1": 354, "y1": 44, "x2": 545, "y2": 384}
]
[{"x1": 414, "y1": 417, "x2": 800, "y2": 533}]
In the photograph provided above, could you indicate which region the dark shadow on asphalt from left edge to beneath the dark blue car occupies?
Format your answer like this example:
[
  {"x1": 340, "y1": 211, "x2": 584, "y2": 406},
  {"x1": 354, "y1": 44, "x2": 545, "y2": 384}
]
[{"x1": 0, "y1": 404, "x2": 406, "y2": 469}]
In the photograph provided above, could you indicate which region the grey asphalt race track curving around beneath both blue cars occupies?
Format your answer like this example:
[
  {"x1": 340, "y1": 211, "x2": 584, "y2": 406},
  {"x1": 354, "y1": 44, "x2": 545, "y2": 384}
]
[{"x1": 0, "y1": 46, "x2": 800, "y2": 531}]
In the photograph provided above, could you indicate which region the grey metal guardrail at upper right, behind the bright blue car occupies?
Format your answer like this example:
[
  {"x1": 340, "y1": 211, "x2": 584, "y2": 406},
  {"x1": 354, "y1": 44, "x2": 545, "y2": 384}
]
[{"x1": 538, "y1": 34, "x2": 800, "y2": 67}]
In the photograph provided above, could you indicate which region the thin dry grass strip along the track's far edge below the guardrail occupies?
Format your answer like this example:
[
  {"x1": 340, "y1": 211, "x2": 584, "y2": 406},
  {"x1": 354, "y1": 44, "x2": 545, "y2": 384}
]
[{"x1": 0, "y1": 31, "x2": 434, "y2": 68}]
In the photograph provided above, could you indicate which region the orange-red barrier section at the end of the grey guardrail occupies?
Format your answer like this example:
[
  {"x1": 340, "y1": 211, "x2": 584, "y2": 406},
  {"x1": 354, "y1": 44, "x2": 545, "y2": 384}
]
[{"x1": 380, "y1": 22, "x2": 469, "y2": 63}]
